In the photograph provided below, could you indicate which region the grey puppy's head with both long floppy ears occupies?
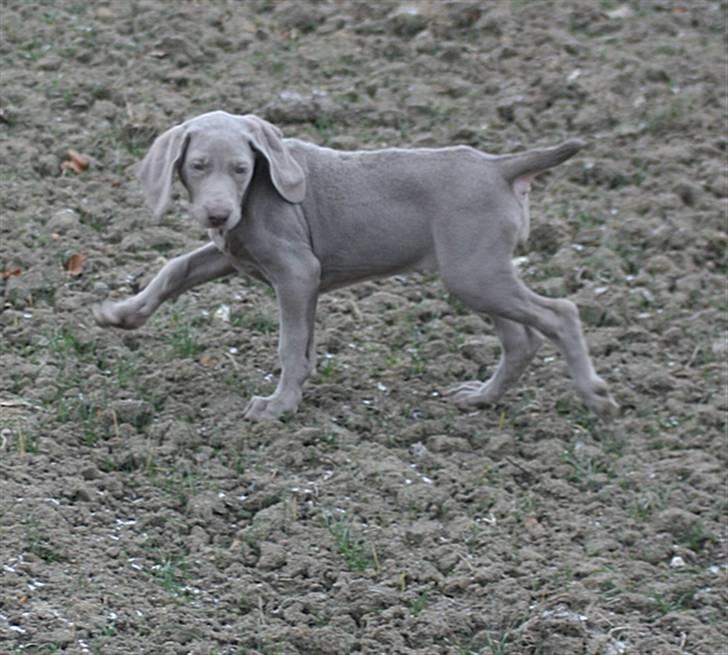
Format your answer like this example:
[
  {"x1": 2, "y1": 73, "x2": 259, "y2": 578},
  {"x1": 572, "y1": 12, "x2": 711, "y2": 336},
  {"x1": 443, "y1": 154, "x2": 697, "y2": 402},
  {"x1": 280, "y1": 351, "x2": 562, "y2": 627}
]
[{"x1": 139, "y1": 111, "x2": 306, "y2": 230}]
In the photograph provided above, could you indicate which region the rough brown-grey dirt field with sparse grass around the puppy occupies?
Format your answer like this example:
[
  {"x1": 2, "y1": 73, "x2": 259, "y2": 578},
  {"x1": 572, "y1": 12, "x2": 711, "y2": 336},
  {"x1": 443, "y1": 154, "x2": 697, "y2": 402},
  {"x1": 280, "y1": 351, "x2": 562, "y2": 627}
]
[{"x1": 0, "y1": 0, "x2": 728, "y2": 655}]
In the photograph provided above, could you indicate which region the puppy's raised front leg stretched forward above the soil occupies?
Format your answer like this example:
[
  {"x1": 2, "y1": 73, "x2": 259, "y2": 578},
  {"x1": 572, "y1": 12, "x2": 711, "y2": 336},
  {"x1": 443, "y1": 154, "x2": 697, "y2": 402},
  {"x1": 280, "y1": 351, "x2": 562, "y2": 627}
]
[{"x1": 92, "y1": 243, "x2": 235, "y2": 329}]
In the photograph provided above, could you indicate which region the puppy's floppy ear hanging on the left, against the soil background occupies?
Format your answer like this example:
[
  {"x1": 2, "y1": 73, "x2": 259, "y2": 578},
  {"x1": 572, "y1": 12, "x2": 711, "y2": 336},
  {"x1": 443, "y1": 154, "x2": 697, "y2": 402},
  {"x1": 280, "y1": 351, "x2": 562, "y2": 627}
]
[{"x1": 138, "y1": 124, "x2": 189, "y2": 218}]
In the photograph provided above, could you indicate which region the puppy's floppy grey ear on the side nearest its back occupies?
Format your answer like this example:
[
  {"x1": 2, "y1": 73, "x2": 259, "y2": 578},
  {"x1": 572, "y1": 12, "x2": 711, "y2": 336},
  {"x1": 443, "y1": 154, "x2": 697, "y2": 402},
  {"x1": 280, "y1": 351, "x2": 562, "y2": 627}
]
[{"x1": 240, "y1": 114, "x2": 306, "y2": 203}]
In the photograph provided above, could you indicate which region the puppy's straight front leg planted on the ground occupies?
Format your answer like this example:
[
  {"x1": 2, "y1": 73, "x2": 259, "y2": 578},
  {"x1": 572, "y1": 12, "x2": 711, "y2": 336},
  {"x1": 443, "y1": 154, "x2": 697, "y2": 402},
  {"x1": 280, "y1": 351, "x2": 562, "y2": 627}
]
[{"x1": 245, "y1": 276, "x2": 318, "y2": 421}]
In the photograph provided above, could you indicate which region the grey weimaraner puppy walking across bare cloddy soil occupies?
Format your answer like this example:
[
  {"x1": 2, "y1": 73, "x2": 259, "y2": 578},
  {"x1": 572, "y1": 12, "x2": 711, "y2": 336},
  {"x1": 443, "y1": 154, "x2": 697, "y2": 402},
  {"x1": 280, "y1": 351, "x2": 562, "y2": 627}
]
[{"x1": 93, "y1": 111, "x2": 617, "y2": 420}]
